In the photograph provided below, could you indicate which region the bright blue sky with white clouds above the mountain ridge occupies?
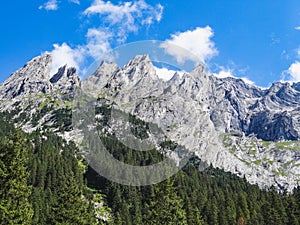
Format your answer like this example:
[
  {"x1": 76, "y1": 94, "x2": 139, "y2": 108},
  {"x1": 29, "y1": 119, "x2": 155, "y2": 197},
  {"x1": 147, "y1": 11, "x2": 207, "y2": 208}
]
[{"x1": 0, "y1": 0, "x2": 300, "y2": 87}]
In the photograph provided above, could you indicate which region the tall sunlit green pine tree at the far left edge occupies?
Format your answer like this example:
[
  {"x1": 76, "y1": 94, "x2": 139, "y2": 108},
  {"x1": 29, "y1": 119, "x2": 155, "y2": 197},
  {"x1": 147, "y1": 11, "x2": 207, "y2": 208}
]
[{"x1": 0, "y1": 131, "x2": 33, "y2": 225}]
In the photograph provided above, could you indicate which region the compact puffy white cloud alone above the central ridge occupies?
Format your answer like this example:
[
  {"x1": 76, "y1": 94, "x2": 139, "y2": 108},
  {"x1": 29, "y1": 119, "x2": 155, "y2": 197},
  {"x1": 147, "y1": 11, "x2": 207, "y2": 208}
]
[{"x1": 161, "y1": 26, "x2": 218, "y2": 63}]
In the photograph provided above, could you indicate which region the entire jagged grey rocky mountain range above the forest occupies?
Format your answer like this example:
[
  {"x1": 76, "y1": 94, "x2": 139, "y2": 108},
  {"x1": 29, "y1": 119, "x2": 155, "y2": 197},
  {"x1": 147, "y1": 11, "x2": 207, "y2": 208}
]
[{"x1": 0, "y1": 54, "x2": 300, "y2": 192}]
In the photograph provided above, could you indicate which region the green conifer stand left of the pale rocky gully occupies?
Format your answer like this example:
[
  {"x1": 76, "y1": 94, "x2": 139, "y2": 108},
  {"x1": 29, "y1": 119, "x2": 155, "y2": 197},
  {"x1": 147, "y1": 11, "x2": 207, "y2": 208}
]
[{"x1": 0, "y1": 120, "x2": 97, "y2": 225}]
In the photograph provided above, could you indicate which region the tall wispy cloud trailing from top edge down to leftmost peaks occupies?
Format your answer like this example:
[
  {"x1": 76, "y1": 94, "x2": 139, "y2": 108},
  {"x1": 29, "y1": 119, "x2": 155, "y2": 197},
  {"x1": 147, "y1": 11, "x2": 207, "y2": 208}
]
[{"x1": 49, "y1": 0, "x2": 163, "y2": 75}]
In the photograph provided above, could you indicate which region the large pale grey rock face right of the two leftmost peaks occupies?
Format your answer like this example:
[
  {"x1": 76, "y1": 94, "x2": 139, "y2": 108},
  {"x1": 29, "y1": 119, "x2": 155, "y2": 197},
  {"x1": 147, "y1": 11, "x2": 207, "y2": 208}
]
[{"x1": 82, "y1": 56, "x2": 300, "y2": 191}]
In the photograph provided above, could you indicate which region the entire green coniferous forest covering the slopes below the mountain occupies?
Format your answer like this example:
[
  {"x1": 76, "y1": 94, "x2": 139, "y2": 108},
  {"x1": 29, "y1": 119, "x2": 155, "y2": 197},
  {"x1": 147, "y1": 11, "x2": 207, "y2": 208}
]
[{"x1": 0, "y1": 116, "x2": 300, "y2": 225}]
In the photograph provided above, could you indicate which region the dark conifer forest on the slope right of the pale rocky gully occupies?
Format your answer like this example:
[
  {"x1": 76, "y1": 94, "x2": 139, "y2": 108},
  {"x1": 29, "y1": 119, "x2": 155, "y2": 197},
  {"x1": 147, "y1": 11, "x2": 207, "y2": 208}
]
[{"x1": 86, "y1": 132, "x2": 300, "y2": 225}]
